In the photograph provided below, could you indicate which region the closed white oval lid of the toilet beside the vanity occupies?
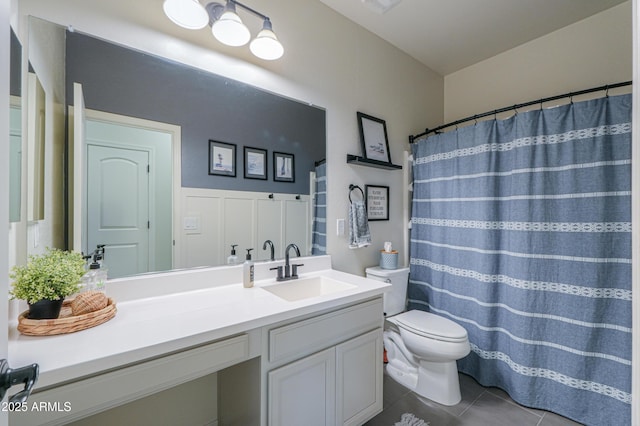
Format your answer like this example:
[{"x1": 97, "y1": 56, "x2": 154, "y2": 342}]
[{"x1": 395, "y1": 311, "x2": 467, "y2": 342}]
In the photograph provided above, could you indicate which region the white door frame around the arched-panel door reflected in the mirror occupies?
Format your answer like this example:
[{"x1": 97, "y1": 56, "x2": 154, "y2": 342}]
[{"x1": 82, "y1": 108, "x2": 182, "y2": 272}]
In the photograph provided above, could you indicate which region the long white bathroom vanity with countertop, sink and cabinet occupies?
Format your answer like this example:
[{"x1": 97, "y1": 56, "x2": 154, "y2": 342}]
[{"x1": 9, "y1": 255, "x2": 390, "y2": 426}]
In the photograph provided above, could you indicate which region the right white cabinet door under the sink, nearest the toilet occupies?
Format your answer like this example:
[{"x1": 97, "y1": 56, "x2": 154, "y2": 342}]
[{"x1": 336, "y1": 329, "x2": 383, "y2": 425}]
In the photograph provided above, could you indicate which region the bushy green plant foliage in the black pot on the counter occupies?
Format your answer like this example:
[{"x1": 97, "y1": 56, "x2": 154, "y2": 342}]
[{"x1": 9, "y1": 248, "x2": 85, "y2": 303}]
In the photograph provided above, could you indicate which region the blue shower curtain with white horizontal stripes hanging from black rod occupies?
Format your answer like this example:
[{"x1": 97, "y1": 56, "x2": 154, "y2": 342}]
[{"x1": 409, "y1": 95, "x2": 631, "y2": 425}]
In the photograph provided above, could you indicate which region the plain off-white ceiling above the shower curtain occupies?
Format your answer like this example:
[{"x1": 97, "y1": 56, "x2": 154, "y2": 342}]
[{"x1": 320, "y1": 0, "x2": 626, "y2": 75}]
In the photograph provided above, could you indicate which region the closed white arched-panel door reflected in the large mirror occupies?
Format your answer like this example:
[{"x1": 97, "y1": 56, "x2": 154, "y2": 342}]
[{"x1": 87, "y1": 145, "x2": 150, "y2": 278}]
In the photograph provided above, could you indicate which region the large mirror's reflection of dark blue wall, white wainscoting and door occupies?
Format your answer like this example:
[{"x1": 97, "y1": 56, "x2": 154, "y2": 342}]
[{"x1": 23, "y1": 17, "x2": 326, "y2": 278}]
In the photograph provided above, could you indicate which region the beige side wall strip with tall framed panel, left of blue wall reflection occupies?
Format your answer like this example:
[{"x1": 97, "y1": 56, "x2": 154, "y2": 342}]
[{"x1": 25, "y1": 16, "x2": 67, "y2": 261}]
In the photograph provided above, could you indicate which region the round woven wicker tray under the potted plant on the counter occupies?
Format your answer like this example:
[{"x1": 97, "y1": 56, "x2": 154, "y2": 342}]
[{"x1": 18, "y1": 298, "x2": 116, "y2": 336}]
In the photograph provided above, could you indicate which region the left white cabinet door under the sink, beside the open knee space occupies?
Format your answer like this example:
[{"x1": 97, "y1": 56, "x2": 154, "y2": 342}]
[{"x1": 268, "y1": 348, "x2": 336, "y2": 426}]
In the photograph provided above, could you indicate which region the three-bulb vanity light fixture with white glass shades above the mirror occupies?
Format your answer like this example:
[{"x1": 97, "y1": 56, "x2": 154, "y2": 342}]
[{"x1": 163, "y1": 0, "x2": 284, "y2": 61}]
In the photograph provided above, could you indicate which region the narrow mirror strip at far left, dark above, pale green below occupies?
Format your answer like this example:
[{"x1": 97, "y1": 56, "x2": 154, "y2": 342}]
[{"x1": 9, "y1": 28, "x2": 22, "y2": 222}]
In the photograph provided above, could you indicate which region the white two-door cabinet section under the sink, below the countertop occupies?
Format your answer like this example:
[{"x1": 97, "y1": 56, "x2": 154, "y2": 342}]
[{"x1": 264, "y1": 298, "x2": 383, "y2": 426}]
